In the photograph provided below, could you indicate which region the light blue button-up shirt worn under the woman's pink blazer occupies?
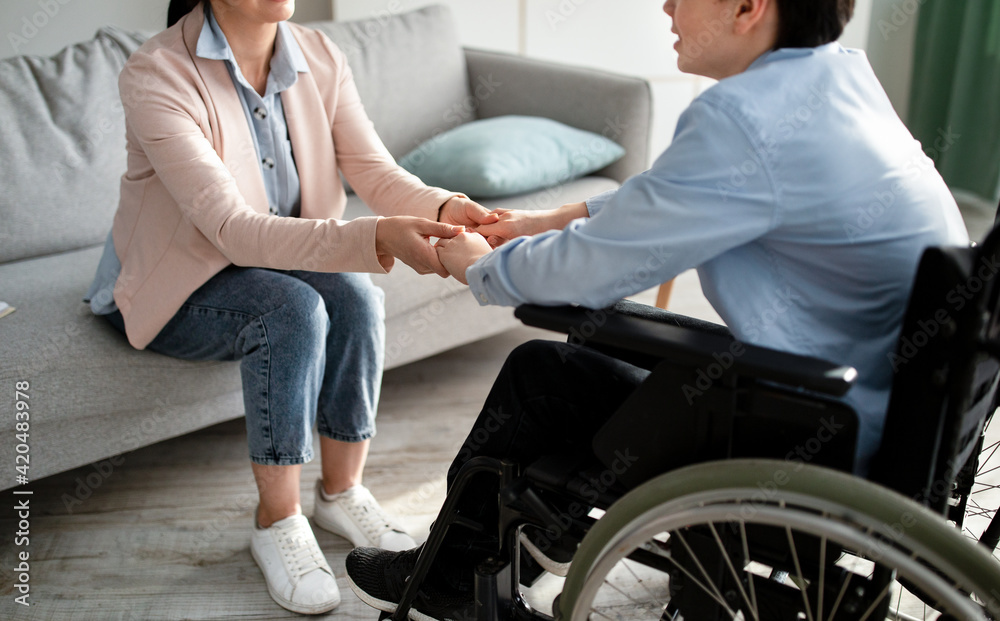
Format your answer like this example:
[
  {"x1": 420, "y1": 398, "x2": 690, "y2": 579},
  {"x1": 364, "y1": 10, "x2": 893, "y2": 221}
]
[{"x1": 84, "y1": 5, "x2": 309, "y2": 315}]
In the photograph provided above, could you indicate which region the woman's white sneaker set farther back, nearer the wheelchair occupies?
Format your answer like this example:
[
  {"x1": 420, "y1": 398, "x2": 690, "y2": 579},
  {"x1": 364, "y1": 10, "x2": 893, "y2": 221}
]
[{"x1": 313, "y1": 480, "x2": 417, "y2": 551}]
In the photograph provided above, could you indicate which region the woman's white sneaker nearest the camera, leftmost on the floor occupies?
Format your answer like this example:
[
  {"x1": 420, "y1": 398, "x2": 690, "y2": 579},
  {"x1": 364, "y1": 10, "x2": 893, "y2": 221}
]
[{"x1": 250, "y1": 514, "x2": 340, "y2": 614}]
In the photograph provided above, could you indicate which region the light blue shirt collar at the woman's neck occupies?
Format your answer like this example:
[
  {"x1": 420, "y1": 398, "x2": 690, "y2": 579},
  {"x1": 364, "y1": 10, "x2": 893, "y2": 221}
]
[{"x1": 195, "y1": 6, "x2": 309, "y2": 95}]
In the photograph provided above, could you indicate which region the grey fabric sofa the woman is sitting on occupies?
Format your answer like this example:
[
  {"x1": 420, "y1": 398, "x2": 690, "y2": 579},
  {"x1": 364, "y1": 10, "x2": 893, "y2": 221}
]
[{"x1": 0, "y1": 7, "x2": 651, "y2": 489}]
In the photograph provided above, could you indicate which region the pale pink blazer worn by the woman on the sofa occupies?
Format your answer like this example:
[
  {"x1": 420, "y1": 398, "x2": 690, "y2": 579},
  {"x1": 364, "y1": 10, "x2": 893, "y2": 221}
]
[{"x1": 112, "y1": 5, "x2": 459, "y2": 349}]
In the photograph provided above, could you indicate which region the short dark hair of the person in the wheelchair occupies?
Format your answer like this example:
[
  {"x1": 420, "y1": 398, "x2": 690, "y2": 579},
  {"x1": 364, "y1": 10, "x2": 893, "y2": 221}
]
[{"x1": 774, "y1": 0, "x2": 854, "y2": 49}]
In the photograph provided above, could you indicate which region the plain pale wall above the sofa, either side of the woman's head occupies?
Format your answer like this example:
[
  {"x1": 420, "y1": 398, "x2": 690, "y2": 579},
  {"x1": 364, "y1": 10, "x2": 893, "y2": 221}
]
[{"x1": 0, "y1": 0, "x2": 332, "y2": 58}]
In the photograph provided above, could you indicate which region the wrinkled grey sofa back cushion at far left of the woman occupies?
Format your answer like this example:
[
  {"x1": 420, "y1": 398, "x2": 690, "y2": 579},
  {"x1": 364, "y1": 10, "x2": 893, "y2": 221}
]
[{"x1": 0, "y1": 28, "x2": 146, "y2": 263}]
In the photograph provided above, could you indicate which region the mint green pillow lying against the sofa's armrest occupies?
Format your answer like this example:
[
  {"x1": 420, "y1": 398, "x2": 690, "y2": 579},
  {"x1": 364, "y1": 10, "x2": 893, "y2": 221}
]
[{"x1": 399, "y1": 116, "x2": 625, "y2": 198}]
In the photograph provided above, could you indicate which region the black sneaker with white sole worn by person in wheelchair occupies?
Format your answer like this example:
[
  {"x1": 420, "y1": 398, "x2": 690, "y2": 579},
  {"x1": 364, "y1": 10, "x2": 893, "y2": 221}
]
[{"x1": 346, "y1": 546, "x2": 476, "y2": 621}]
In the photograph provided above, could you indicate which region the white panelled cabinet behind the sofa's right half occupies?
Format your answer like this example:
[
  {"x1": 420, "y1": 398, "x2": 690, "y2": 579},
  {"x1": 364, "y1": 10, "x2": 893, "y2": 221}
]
[{"x1": 331, "y1": 0, "x2": 873, "y2": 157}]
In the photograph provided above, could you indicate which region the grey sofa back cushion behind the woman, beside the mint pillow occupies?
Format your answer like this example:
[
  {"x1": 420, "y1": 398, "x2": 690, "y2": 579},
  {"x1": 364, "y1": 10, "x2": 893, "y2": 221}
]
[{"x1": 307, "y1": 6, "x2": 476, "y2": 158}]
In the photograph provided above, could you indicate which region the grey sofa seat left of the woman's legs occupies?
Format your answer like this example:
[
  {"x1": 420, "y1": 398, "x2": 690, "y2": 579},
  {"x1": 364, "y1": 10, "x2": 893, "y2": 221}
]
[{"x1": 0, "y1": 246, "x2": 243, "y2": 487}]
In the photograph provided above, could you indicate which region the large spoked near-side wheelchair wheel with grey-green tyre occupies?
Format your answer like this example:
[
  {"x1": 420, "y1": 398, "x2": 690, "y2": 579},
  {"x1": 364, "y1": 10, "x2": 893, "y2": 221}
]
[{"x1": 555, "y1": 460, "x2": 1000, "y2": 621}]
